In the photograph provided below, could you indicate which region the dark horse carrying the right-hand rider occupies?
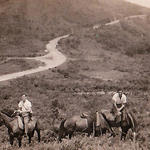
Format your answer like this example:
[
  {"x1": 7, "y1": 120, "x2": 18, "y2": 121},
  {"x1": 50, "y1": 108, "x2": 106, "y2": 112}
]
[{"x1": 102, "y1": 109, "x2": 137, "y2": 141}]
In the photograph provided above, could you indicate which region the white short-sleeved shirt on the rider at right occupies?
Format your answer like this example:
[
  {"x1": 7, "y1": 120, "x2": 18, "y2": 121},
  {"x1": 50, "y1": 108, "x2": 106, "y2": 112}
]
[{"x1": 112, "y1": 93, "x2": 127, "y2": 104}]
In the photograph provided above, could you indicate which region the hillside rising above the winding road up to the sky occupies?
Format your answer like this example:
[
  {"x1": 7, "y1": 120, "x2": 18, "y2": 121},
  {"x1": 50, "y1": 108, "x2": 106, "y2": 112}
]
[{"x1": 0, "y1": 0, "x2": 149, "y2": 56}]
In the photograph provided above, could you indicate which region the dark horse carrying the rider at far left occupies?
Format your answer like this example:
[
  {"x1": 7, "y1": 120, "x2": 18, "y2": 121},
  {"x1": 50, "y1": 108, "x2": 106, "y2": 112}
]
[{"x1": 0, "y1": 109, "x2": 40, "y2": 147}]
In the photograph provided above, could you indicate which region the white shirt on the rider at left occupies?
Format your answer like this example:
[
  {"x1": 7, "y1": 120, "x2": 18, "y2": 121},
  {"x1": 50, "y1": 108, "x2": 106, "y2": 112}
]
[{"x1": 18, "y1": 99, "x2": 32, "y2": 113}]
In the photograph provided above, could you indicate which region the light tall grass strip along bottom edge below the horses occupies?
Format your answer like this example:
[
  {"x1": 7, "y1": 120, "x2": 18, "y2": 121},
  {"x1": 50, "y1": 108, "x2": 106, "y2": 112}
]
[{"x1": 1, "y1": 136, "x2": 145, "y2": 150}]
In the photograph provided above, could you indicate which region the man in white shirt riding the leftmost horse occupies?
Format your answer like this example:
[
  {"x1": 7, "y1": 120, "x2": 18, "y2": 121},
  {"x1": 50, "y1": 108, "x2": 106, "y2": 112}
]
[{"x1": 18, "y1": 95, "x2": 32, "y2": 135}]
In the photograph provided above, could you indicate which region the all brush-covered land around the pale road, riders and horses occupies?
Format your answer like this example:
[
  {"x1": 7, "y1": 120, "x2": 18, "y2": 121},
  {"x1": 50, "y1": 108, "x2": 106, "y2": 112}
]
[{"x1": 0, "y1": 0, "x2": 150, "y2": 150}]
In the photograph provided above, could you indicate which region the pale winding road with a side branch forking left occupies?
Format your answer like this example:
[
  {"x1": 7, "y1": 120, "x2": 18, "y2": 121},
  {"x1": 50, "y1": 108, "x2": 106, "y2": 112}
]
[{"x1": 0, "y1": 35, "x2": 69, "y2": 81}]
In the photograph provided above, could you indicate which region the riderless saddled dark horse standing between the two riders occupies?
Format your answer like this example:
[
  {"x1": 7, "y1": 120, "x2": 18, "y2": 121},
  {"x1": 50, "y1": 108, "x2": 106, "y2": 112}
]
[{"x1": 59, "y1": 114, "x2": 115, "y2": 141}]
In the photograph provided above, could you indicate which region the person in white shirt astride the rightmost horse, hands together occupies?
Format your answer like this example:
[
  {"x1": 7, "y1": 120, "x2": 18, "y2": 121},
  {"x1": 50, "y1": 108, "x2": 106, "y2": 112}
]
[{"x1": 112, "y1": 89, "x2": 127, "y2": 118}]
